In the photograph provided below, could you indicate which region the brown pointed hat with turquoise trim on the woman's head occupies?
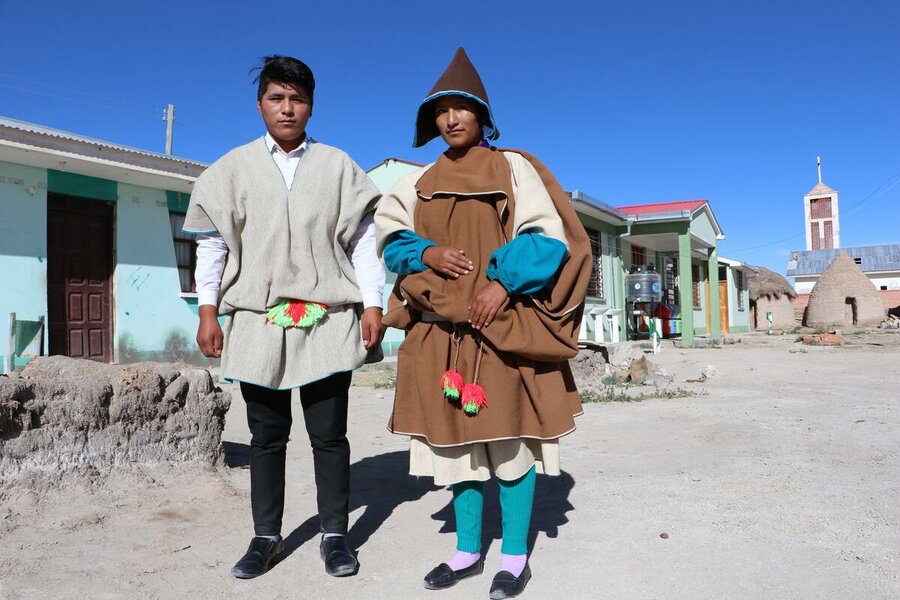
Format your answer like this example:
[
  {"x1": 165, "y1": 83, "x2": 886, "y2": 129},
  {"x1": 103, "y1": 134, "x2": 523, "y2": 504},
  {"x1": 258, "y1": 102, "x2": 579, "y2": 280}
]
[{"x1": 413, "y1": 48, "x2": 500, "y2": 148}]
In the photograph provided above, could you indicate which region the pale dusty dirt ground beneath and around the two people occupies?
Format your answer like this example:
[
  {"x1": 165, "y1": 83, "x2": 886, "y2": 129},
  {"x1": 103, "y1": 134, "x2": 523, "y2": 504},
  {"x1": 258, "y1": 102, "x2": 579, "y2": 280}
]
[{"x1": 0, "y1": 332, "x2": 900, "y2": 600}]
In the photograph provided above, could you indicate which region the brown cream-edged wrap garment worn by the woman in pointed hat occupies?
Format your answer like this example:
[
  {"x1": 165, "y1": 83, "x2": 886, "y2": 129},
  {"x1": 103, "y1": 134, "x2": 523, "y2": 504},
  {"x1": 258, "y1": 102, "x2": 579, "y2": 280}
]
[{"x1": 376, "y1": 147, "x2": 591, "y2": 446}]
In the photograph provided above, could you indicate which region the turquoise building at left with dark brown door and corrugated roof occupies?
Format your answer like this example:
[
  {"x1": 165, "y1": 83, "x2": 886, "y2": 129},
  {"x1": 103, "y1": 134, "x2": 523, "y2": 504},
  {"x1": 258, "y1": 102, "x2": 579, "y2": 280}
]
[{"x1": 0, "y1": 118, "x2": 205, "y2": 371}]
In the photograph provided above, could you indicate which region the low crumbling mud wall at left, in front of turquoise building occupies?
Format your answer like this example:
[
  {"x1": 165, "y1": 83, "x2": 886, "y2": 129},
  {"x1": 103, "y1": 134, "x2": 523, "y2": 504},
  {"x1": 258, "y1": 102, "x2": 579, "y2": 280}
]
[{"x1": 0, "y1": 356, "x2": 231, "y2": 478}]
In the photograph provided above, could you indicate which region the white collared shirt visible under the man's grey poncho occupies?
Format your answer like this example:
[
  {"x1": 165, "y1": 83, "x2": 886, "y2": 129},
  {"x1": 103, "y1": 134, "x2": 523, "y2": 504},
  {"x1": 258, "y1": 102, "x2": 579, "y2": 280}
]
[{"x1": 194, "y1": 133, "x2": 385, "y2": 308}]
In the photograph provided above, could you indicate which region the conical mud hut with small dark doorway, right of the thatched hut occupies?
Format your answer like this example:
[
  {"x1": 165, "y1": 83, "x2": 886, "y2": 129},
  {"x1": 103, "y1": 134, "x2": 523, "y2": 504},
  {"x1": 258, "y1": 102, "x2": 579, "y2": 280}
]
[{"x1": 803, "y1": 252, "x2": 884, "y2": 327}]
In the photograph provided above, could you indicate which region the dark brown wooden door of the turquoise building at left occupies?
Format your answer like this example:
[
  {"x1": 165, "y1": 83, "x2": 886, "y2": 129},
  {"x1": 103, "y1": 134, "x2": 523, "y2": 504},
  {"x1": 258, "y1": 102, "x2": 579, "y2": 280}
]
[{"x1": 47, "y1": 194, "x2": 113, "y2": 362}]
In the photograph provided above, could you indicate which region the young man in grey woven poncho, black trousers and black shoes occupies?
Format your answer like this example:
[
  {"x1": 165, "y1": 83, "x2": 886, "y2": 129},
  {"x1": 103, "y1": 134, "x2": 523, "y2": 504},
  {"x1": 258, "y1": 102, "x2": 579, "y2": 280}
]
[{"x1": 184, "y1": 56, "x2": 384, "y2": 578}]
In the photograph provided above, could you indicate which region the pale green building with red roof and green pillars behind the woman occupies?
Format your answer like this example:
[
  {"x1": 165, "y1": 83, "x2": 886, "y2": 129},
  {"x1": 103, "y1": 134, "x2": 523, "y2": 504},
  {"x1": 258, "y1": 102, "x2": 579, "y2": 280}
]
[{"x1": 368, "y1": 158, "x2": 753, "y2": 351}]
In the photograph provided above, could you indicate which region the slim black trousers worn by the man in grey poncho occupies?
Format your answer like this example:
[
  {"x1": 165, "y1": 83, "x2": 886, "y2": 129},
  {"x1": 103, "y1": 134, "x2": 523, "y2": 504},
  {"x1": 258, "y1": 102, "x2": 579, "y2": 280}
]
[{"x1": 241, "y1": 371, "x2": 351, "y2": 535}]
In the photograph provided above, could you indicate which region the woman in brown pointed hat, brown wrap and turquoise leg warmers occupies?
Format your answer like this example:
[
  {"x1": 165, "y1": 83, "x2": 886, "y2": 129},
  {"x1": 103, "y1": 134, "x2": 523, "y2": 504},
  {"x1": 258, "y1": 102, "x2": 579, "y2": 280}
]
[{"x1": 375, "y1": 48, "x2": 591, "y2": 598}]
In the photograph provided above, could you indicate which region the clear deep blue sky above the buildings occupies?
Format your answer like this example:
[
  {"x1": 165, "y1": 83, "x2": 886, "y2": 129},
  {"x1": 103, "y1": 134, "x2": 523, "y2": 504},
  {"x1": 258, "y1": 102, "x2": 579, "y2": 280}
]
[{"x1": 0, "y1": 0, "x2": 900, "y2": 273}]
